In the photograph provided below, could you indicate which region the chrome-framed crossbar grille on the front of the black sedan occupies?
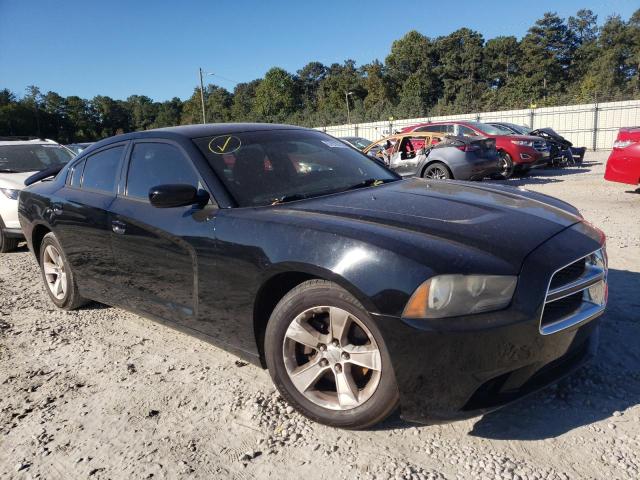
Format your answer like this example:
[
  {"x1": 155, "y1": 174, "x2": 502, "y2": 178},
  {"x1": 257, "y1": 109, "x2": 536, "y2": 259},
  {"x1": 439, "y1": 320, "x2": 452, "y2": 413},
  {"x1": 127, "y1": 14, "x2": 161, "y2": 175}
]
[{"x1": 540, "y1": 248, "x2": 607, "y2": 335}]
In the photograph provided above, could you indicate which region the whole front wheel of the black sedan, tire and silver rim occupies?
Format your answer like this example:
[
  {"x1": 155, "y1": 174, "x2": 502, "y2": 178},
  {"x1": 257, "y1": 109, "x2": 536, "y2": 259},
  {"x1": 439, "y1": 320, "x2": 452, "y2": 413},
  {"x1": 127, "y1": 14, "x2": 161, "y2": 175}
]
[{"x1": 265, "y1": 280, "x2": 398, "y2": 429}]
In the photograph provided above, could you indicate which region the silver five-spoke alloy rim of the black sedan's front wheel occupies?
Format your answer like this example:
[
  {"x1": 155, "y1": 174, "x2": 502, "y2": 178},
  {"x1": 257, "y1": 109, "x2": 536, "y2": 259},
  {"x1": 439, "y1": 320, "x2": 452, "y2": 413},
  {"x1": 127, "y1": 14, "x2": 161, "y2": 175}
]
[{"x1": 282, "y1": 306, "x2": 382, "y2": 410}]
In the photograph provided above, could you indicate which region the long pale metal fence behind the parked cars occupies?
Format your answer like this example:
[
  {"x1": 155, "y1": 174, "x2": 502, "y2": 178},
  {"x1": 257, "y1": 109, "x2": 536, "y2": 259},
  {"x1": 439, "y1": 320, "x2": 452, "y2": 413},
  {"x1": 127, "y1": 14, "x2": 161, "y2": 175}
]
[{"x1": 317, "y1": 100, "x2": 640, "y2": 150}]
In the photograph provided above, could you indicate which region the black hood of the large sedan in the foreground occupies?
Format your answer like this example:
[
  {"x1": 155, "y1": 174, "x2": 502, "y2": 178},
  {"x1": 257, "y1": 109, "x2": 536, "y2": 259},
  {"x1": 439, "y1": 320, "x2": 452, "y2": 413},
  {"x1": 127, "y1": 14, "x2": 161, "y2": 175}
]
[{"x1": 283, "y1": 179, "x2": 582, "y2": 269}]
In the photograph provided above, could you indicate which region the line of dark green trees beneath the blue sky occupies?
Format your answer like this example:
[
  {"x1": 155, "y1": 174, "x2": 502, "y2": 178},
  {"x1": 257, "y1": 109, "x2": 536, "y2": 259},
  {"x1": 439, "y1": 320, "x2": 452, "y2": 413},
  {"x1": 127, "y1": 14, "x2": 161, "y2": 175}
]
[{"x1": 0, "y1": 9, "x2": 640, "y2": 142}]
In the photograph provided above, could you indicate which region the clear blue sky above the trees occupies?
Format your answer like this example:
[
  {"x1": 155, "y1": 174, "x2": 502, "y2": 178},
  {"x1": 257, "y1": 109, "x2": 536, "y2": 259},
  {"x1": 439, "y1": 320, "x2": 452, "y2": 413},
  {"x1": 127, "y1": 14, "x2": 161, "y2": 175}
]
[{"x1": 0, "y1": 0, "x2": 640, "y2": 101}]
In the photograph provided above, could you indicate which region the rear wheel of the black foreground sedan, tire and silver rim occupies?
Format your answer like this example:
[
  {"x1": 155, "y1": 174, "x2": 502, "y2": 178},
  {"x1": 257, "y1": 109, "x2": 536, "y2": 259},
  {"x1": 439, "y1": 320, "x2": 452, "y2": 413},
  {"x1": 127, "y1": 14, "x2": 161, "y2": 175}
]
[{"x1": 40, "y1": 233, "x2": 87, "y2": 310}]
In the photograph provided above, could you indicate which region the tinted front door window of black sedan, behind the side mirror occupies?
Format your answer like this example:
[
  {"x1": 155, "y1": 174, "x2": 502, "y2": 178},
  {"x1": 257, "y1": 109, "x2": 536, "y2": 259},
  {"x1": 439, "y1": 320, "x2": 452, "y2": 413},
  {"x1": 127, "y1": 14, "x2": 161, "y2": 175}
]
[{"x1": 127, "y1": 142, "x2": 201, "y2": 200}]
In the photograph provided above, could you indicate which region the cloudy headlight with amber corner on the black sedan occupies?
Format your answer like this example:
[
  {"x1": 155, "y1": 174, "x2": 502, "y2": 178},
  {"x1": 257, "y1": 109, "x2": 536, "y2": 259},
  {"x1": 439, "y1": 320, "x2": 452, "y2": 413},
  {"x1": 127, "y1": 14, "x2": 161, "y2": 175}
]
[{"x1": 402, "y1": 275, "x2": 518, "y2": 318}]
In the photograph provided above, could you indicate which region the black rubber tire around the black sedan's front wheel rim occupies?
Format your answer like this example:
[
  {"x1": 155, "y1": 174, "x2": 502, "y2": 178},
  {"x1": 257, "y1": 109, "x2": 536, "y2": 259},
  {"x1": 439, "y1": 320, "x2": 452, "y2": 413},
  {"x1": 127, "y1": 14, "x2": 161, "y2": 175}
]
[{"x1": 264, "y1": 280, "x2": 398, "y2": 429}]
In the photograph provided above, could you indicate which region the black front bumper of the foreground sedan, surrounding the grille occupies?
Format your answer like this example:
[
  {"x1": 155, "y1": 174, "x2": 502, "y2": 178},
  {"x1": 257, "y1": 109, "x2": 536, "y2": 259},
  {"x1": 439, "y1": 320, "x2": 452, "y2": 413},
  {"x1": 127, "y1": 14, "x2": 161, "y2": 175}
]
[{"x1": 374, "y1": 224, "x2": 601, "y2": 423}]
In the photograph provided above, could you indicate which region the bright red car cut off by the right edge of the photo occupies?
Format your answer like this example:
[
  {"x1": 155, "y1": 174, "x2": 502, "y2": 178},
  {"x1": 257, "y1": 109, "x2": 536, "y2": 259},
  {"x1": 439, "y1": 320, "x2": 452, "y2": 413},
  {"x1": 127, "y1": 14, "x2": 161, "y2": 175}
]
[{"x1": 604, "y1": 127, "x2": 640, "y2": 185}]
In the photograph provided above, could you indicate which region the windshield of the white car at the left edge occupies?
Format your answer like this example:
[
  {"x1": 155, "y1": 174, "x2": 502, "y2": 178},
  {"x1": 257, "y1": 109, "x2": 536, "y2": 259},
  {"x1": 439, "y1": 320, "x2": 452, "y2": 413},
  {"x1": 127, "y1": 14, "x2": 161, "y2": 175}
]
[{"x1": 0, "y1": 144, "x2": 73, "y2": 173}]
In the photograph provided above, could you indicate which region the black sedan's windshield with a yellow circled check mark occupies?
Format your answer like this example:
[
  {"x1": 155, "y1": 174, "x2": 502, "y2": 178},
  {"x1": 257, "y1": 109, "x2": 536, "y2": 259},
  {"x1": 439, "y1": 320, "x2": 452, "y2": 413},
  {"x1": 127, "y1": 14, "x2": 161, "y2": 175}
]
[{"x1": 194, "y1": 130, "x2": 400, "y2": 207}]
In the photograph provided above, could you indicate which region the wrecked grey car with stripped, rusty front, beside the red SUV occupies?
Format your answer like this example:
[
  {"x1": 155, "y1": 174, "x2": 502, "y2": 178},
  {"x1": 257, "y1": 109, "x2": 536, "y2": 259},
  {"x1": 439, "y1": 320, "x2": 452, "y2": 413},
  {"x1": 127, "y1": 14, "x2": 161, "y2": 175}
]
[{"x1": 364, "y1": 132, "x2": 499, "y2": 180}]
